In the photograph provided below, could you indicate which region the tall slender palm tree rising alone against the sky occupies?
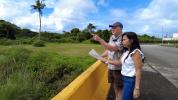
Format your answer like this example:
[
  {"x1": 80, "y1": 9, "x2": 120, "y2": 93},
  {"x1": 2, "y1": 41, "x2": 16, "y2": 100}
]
[{"x1": 31, "y1": 0, "x2": 46, "y2": 40}]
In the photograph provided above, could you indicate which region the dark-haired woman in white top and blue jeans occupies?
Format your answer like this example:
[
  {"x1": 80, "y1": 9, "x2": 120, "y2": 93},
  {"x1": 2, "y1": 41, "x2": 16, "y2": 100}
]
[{"x1": 102, "y1": 32, "x2": 144, "y2": 100}]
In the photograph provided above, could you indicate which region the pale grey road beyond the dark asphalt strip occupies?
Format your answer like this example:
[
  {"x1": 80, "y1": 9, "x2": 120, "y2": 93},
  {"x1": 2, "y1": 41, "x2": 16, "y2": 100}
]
[{"x1": 142, "y1": 45, "x2": 178, "y2": 88}]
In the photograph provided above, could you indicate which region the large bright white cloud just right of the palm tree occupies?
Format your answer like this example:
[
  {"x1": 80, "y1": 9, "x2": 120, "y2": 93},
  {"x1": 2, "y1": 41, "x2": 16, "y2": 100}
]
[{"x1": 45, "y1": 0, "x2": 97, "y2": 31}]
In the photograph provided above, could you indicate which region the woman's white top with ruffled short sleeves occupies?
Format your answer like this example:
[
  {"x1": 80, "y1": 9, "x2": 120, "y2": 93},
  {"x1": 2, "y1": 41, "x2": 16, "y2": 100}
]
[{"x1": 121, "y1": 49, "x2": 144, "y2": 77}]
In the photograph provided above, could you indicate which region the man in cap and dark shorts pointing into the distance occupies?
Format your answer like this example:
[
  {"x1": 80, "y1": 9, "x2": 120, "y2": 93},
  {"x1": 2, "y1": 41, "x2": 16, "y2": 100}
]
[{"x1": 93, "y1": 22, "x2": 123, "y2": 100}]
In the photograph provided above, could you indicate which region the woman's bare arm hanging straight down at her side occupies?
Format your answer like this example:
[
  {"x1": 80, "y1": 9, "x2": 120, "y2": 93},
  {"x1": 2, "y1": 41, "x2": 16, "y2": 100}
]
[{"x1": 132, "y1": 51, "x2": 143, "y2": 97}]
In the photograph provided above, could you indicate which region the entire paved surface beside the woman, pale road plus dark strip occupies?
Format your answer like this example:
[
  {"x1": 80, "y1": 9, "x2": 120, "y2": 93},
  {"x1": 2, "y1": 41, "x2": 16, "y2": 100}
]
[{"x1": 107, "y1": 45, "x2": 178, "y2": 100}]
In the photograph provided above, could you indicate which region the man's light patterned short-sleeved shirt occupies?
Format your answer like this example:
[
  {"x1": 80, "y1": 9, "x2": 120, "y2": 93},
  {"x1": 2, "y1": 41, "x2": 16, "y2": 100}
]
[{"x1": 108, "y1": 35, "x2": 123, "y2": 70}]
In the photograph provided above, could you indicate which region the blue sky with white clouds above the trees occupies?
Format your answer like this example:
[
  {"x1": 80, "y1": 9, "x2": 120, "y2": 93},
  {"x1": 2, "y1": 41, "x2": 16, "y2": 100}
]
[{"x1": 0, "y1": 0, "x2": 178, "y2": 37}]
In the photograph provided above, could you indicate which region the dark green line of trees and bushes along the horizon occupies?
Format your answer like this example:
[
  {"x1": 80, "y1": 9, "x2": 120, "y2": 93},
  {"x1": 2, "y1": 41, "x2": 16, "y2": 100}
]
[{"x1": 0, "y1": 20, "x2": 175, "y2": 45}]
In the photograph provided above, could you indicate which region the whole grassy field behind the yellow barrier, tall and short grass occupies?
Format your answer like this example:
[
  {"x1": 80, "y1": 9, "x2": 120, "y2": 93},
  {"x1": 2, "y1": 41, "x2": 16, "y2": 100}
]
[{"x1": 0, "y1": 43, "x2": 103, "y2": 100}]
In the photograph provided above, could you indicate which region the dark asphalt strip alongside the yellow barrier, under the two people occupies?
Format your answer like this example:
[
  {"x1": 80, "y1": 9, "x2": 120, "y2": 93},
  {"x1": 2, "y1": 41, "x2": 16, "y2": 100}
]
[{"x1": 107, "y1": 62, "x2": 178, "y2": 100}]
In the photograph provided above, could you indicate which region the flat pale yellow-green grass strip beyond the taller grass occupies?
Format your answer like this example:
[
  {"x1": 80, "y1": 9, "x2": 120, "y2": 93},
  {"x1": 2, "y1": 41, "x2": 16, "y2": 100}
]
[{"x1": 0, "y1": 43, "x2": 103, "y2": 57}]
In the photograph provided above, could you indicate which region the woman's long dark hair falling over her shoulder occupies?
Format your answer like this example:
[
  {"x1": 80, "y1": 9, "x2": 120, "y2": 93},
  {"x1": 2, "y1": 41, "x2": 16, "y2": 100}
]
[{"x1": 122, "y1": 32, "x2": 141, "y2": 61}]
